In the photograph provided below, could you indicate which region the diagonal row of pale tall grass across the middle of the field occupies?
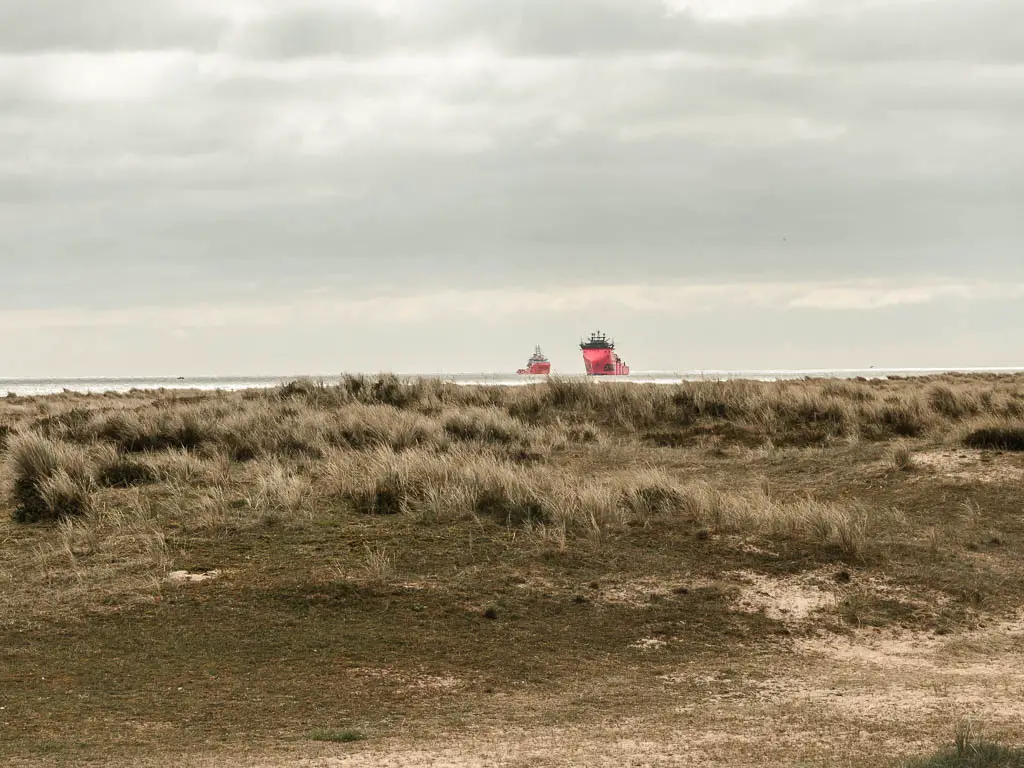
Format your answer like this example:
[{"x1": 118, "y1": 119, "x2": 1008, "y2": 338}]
[{"x1": 326, "y1": 450, "x2": 884, "y2": 557}]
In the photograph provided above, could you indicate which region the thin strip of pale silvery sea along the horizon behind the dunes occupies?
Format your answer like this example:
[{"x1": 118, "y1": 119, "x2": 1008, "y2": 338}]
[{"x1": 0, "y1": 368, "x2": 1024, "y2": 396}]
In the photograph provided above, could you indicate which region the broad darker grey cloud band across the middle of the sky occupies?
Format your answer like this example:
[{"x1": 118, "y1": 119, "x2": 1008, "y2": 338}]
[{"x1": 0, "y1": 129, "x2": 1024, "y2": 309}]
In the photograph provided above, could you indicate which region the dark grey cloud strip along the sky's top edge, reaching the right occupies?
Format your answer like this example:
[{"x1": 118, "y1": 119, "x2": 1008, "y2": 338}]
[{"x1": 228, "y1": 0, "x2": 1024, "y2": 65}]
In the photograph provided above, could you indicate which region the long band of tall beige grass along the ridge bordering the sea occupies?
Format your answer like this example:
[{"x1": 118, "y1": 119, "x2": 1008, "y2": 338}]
[{"x1": 14, "y1": 376, "x2": 1024, "y2": 468}]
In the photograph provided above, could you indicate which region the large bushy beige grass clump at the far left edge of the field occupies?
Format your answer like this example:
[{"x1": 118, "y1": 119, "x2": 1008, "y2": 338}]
[{"x1": 8, "y1": 433, "x2": 93, "y2": 522}]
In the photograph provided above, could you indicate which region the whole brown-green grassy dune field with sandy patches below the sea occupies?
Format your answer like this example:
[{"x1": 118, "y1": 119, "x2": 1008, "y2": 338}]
[{"x1": 0, "y1": 375, "x2": 1024, "y2": 766}]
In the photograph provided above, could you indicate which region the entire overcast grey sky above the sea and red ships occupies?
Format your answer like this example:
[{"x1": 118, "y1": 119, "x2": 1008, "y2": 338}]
[{"x1": 0, "y1": 0, "x2": 1024, "y2": 377}]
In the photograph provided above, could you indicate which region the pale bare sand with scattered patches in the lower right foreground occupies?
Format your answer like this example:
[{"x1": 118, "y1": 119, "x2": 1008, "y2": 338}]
[{"x1": 121, "y1": 571, "x2": 1024, "y2": 768}]
